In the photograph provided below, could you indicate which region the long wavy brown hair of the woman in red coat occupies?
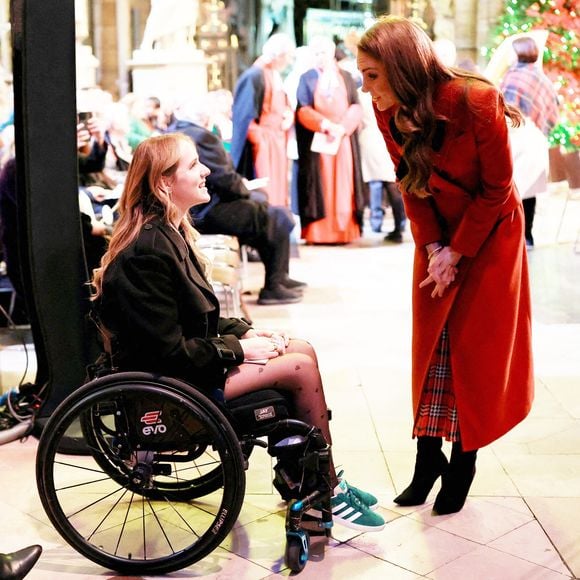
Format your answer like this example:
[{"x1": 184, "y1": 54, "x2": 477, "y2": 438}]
[{"x1": 358, "y1": 16, "x2": 521, "y2": 197}]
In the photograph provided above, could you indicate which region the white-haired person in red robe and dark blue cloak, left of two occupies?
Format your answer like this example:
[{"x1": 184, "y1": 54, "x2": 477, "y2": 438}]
[{"x1": 231, "y1": 33, "x2": 296, "y2": 207}]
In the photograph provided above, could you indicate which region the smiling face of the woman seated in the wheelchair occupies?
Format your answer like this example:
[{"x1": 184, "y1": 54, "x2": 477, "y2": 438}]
[{"x1": 167, "y1": 141, "x2": 210, "y2": 215}]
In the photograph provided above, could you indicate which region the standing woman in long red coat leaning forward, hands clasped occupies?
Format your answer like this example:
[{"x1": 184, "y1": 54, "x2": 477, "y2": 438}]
[{"x1": 358, "y1": 17, "x2": 533, "y2": 514}]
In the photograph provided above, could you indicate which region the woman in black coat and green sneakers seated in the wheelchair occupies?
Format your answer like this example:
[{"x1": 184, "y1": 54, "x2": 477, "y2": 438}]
[{"x1": 93, "y1": 133, "x2": 384, "y2": 531}]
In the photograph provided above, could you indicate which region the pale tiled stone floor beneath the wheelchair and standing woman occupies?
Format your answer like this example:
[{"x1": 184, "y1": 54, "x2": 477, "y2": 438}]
[{"x1": 0, "y1": 187, "x2": 580, "y2": 580}]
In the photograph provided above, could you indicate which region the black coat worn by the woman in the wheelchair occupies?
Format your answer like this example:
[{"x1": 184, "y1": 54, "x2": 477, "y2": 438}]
[{"x1": 99, "y1": 218, "x2": 250, "y2": 391}]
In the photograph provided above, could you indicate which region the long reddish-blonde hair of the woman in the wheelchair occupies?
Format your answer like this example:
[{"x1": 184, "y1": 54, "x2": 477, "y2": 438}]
[{"x1": 92, "y1": 133, "x2": 207, "y2": 300}]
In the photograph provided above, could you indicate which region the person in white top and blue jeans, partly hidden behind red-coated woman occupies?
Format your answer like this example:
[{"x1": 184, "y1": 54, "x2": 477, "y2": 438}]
[{"x1": 359, "y1": 89, "x2": 406, "y2": 244}]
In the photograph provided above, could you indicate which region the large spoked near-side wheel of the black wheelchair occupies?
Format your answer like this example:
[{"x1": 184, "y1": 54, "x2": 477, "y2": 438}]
[{"x1": 36, "y1": 373, "x2": 245, "y2": 575}]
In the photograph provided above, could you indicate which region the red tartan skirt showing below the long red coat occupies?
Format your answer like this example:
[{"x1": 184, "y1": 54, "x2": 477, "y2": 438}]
[{"x1": 413, "y1": 326, "x2": 460, "y2": 442}]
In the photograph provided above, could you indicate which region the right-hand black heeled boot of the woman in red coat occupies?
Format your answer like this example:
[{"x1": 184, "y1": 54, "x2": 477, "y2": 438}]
[{"x1": 433, "y1": 442, "x2": 477, "y2": 516}]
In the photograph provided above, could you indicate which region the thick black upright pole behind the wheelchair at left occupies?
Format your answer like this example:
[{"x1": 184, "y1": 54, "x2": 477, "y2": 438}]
[{"x1": 11, "y1": 0, "x2": 93, "y2": 420}]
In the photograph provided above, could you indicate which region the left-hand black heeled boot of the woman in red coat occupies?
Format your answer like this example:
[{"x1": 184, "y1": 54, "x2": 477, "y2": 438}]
[{"x1": 394, "y1": 437, "x2": 448, "y2": 506}]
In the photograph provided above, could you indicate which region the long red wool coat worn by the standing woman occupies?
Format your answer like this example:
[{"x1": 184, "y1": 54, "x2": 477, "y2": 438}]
[{"x1": 375, "y1": 79, "x2": 533, "y2": 450}]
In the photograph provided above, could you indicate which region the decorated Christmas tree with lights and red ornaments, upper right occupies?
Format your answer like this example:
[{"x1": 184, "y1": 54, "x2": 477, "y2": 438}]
[{"x1": 485, "y1": 0, "x2": 580, "y2": 151}]
